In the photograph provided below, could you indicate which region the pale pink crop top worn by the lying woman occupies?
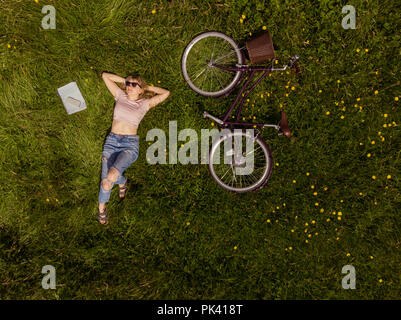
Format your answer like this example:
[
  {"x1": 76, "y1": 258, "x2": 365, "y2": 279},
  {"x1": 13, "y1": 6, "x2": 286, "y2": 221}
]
[{"x1": 113, "y1": 88, "x2": 149, "y2": 127}]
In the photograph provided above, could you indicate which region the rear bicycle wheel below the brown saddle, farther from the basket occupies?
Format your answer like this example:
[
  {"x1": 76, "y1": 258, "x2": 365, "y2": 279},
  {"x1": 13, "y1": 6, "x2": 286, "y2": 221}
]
[{"x1": 209, "y1": 131, "x2": 273, "y2": 192}]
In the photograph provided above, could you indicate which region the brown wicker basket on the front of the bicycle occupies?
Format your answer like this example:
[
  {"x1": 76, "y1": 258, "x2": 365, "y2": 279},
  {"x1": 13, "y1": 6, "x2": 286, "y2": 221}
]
[{"x1": 246, "y1": 32, "x2": 276, "y2": 64}]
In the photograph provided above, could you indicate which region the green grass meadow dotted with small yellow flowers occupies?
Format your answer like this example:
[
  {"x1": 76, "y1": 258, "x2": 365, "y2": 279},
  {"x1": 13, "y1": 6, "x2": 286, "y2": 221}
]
[{"x1": 0, "y1": 0, "x2": 401, "y2": 299}]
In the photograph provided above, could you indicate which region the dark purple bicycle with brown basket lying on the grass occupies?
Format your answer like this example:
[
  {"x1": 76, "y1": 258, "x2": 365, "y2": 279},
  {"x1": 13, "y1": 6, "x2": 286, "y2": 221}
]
[{"x1": 181, "y1": 31, "x2": 301, "y2": 192}]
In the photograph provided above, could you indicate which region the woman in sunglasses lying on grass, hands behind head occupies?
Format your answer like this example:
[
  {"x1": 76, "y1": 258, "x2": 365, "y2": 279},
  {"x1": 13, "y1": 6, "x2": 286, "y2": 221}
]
[{"x1": 98, "y1": 72, "x2": 170, "y2": 224}]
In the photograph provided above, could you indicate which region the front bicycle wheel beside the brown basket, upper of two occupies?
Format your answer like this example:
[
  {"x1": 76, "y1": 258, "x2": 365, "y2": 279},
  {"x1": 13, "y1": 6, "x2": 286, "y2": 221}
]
[{"x1": 181, "y1": 31, "x2": 243, "y2": 97}]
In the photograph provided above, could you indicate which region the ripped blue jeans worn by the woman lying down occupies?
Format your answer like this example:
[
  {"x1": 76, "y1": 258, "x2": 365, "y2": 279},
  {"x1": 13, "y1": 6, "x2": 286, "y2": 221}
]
[{"x1": 99, "y1": 132, "x2": 139, "y2": 204}]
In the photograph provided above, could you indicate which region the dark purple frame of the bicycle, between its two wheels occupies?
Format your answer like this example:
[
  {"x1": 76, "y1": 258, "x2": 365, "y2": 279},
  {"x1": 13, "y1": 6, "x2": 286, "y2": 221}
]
[{"x1": 204, "y1": 51, "x2": 294, "y2": 130}]
